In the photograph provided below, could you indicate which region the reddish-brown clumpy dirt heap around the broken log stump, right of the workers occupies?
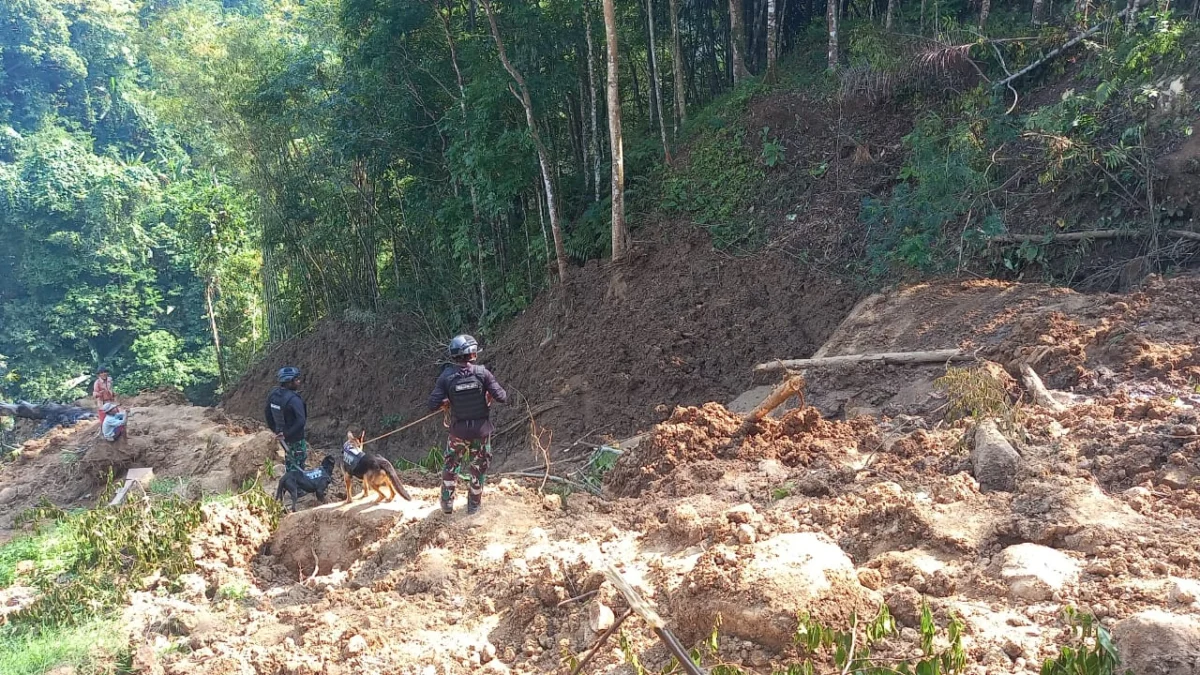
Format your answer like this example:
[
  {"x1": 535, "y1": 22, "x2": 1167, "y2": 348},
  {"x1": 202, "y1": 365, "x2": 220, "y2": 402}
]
[{"x1": 605, "y1": 402, "x2": 882, "y2": 496}]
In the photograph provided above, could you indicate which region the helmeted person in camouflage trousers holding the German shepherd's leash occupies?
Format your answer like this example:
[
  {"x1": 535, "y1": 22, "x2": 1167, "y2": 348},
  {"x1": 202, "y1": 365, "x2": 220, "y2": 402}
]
[{"x1": 428, "y1": 335, "x2": 509, "y2": 515}]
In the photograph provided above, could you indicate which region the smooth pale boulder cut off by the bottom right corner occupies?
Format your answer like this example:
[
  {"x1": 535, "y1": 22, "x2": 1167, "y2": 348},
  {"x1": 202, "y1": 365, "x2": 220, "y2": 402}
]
[{"x1": 1112, "y1": 609, "x2": 1200, "y2": 675}]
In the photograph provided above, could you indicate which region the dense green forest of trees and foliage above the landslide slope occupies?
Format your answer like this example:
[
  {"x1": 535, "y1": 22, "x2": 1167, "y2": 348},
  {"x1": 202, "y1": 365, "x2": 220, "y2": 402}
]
[{"x1": 0, "y1": 0, "x2": 1195, "y2": 400}]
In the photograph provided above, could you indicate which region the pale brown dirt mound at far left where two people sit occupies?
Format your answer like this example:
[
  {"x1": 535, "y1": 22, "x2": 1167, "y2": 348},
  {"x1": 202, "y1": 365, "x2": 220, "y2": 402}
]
[{"x1": 0, "y1": 405, "x2": 278, "y2": 528}]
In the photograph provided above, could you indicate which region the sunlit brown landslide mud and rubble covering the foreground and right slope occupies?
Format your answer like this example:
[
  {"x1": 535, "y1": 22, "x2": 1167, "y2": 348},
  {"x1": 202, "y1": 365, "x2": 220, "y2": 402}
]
[{"x1": 0, "y1": 270, "x2": 1200, "y2": 675}]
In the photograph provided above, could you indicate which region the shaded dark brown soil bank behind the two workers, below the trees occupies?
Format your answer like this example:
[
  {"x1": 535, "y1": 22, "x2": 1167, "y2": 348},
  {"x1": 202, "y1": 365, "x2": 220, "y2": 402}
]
[{"x1": 223, "y1": 226, "x2": 859, "y2": 461}]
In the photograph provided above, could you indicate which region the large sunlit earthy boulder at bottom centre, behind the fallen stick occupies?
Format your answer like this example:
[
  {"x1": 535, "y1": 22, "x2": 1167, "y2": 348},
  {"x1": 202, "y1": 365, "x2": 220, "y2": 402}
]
[{"x1": 671, "y1": 532, "x2": 882, "y2": 650}]
